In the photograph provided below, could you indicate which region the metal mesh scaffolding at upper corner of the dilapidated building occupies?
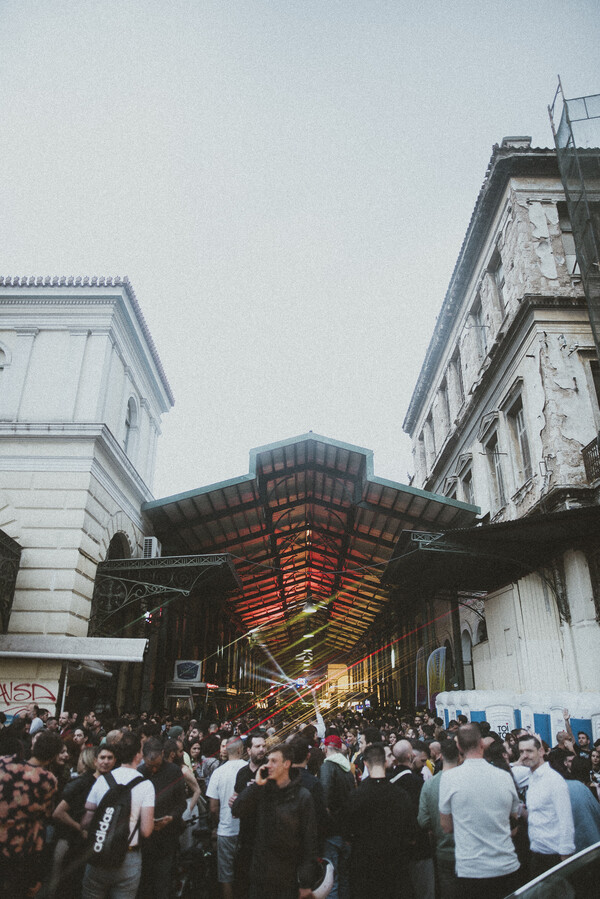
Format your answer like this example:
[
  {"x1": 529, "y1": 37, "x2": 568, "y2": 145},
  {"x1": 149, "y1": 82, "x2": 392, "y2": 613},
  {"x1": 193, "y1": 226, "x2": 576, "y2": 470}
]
[{"x1": 548, "y1": 78, "x2": 600, "y2": 370}]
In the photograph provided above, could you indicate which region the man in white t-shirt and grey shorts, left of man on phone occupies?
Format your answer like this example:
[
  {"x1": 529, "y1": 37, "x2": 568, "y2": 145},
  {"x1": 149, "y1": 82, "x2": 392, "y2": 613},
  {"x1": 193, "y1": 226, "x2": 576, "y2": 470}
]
[{"x1": 206, "y1": 737, "x2": 246, "y2": 899}]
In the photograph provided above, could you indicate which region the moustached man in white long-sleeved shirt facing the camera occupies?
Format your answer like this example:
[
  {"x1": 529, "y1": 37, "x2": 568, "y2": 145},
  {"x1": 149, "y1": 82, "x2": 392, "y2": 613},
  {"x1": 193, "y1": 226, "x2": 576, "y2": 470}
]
[{"x1": 519, "y1": 734, "x2": 575, "y2": 878}]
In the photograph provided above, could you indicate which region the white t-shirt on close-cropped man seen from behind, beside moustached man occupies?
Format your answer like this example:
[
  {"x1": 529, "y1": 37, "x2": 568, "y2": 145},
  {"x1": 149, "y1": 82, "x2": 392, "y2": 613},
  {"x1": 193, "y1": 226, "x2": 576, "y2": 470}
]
[{"x1": 440, "y1": 759, "x2": 520, "y2": 878}]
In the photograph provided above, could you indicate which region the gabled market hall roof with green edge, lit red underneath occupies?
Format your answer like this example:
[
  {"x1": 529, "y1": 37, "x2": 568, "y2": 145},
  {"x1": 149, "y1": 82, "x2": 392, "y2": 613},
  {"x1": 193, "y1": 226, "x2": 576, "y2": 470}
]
[{"x1": 143, "y1": 432, "x2": 479, "y2": 673}]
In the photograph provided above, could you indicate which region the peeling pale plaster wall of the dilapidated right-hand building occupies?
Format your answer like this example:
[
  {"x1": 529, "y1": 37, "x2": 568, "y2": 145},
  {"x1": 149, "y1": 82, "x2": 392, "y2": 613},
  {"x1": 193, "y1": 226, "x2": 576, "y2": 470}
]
[{"x1": 404, "y1": 151, "x2": 600, "y2": 692}]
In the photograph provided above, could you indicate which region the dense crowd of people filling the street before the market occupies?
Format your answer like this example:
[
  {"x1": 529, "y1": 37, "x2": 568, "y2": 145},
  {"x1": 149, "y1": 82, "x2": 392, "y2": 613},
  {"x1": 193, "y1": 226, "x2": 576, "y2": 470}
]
[{"x1": 0, "y1": 697, "x2": 600, "y2": 899}]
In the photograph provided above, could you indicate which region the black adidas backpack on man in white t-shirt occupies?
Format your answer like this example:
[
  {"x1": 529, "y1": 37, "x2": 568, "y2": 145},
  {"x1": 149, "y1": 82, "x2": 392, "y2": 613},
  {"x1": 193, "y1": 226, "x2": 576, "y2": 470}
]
[{"x1": 87, "y1": 772, "x2": 145, "y2": 868}]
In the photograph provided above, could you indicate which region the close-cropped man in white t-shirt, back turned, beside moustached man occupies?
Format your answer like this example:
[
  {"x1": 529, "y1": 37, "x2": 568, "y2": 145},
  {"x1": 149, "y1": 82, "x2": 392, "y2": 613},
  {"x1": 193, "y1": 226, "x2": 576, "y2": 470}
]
[{"x1": 439, "y1": 723, "x2": 520, "y2": 899}]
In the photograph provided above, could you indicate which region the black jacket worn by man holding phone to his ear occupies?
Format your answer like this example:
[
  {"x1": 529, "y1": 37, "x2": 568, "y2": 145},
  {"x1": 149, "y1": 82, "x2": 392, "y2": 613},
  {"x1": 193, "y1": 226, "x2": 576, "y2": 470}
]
[{"x1": 231, "y1": 774, "x2": 317, "y2": 889}]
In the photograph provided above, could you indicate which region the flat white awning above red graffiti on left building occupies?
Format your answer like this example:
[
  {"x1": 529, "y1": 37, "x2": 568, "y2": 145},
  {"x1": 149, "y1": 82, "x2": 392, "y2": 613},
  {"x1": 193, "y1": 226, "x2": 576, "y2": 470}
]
[{"x1": 0, "y1": 634, "x2": 148, "y2": 662}]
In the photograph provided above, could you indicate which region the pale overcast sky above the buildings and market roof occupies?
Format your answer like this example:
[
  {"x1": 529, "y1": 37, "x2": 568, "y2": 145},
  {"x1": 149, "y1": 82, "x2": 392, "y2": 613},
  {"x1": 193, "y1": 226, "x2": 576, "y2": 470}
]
[{"x1": 0, "y1": 0, "x2": 600, "y2": 497}]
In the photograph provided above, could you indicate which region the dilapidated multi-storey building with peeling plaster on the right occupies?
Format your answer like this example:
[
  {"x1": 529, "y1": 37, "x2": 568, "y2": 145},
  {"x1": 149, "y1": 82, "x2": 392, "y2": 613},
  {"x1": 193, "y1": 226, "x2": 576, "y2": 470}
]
[{"x1": 404, "y1": 138, "x2": 600, "y2": 716}]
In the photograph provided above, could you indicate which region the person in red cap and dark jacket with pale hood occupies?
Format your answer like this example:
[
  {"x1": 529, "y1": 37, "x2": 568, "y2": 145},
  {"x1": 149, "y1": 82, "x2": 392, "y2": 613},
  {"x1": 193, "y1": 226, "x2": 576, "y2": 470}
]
[{"x1": 319, "y1": 734, "x2": 355, "y2": 899}]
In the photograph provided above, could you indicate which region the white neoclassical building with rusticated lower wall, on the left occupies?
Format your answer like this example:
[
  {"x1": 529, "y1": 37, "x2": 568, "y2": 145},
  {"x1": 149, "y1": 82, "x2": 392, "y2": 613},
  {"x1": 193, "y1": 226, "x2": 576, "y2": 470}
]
[{"x1": 0, "y1": 278, "x2": 173, "y2": 711}]
